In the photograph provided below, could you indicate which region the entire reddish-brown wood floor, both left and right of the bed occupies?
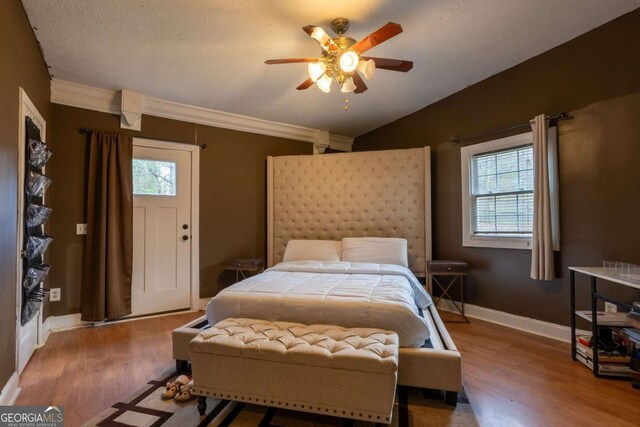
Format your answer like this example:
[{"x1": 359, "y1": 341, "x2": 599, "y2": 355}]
[{"x1": 16, "y1": 313, "x2": 640, "y2": 427}]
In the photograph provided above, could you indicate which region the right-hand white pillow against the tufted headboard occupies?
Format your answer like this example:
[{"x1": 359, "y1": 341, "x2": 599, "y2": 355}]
[{"x1": 342, "y1": 237, "x2": 409, "y2": 267}]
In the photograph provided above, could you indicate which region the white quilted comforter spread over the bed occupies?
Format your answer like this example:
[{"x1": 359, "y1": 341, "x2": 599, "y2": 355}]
[{"x1": 207, "y1": 261, "x2": 431, "y2": 347}]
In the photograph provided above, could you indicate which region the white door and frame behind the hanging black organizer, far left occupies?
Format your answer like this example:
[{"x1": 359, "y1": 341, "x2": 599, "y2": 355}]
[{"x1": 16, "y1": 88, "x2": 47, "y2": 373}]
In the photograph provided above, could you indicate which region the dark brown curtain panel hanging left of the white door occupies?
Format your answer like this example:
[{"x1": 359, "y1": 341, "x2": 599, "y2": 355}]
[{"x1": 82, "y1": 131, "x2": 133, "y2": 321}]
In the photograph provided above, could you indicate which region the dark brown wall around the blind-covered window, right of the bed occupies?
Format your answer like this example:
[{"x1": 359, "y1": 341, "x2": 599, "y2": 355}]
[{"x1": 354, "y1": 9, "x2": 640, "y2": 324}]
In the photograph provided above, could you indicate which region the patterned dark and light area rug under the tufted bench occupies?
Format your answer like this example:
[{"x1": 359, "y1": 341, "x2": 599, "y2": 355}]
[{"x1": 83, "y1": 369, "x2": 478, "y2": 427}]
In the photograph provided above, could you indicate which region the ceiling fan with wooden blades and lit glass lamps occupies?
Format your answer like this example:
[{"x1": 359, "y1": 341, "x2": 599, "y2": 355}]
[{"x1": 265, "y1": 18, "x2": 413, "y2": 93}]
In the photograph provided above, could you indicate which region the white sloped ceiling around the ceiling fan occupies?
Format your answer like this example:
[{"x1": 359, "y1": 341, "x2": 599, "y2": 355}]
[{"x1": 23, "y1": 0, "x2": 640, "y2": 136}]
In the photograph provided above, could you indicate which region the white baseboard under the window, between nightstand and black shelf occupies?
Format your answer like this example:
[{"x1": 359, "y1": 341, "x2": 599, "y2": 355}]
[{"x1": 438, "y1": 298, "x2": 591, "y2": 343}]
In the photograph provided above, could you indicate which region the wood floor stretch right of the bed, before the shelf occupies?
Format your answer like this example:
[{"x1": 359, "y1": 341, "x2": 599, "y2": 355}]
[{"x1": 443, "y1": 315, "x2": 640, "y2": 427}]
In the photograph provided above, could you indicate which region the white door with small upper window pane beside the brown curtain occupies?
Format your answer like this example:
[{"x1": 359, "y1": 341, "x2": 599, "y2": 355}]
[{"x1": 131, "y1": 145, "x2": 191, "y2": 316}]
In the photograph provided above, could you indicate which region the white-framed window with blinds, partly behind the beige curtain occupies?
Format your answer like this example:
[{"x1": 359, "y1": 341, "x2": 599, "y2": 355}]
[{"x1": 461, "y1": 128, "x2": 559, "y2": 249}]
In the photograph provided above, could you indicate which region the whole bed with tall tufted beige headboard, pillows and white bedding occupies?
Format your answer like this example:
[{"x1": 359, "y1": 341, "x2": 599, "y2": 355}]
[{"x1": 173, "y1": 147, "x2": 462, "y2": 404}]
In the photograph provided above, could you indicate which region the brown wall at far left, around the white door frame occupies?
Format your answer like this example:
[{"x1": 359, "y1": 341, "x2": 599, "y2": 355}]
[{"x1": 0, "y1": 0, "x2": 51, "y2": 390}]
